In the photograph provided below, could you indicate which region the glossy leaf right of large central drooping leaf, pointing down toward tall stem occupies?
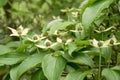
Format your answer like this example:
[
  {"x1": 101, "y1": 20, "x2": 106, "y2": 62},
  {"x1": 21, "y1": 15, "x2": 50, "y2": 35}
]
[{"x1": 63, "y1": 53, "x2": 94, "y2": 67}]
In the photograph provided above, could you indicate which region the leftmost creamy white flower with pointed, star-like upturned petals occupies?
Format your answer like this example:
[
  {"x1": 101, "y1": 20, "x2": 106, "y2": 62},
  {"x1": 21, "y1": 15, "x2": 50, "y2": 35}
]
[{"x1": 8, "y1": 25, "x2": 29, "y2": 37}]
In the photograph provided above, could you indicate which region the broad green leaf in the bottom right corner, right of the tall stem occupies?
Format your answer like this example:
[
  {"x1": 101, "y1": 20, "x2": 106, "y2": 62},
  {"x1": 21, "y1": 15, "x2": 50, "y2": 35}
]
[{"x1": 102, "y1": 69, "x2": 120, "y2": 80}]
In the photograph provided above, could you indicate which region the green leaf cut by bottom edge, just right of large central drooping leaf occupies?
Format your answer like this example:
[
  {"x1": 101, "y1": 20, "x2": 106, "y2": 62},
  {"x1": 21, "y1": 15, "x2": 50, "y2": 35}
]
[{"x1": 66, "y1": 70, "x2": 93, "y2": 80}]
